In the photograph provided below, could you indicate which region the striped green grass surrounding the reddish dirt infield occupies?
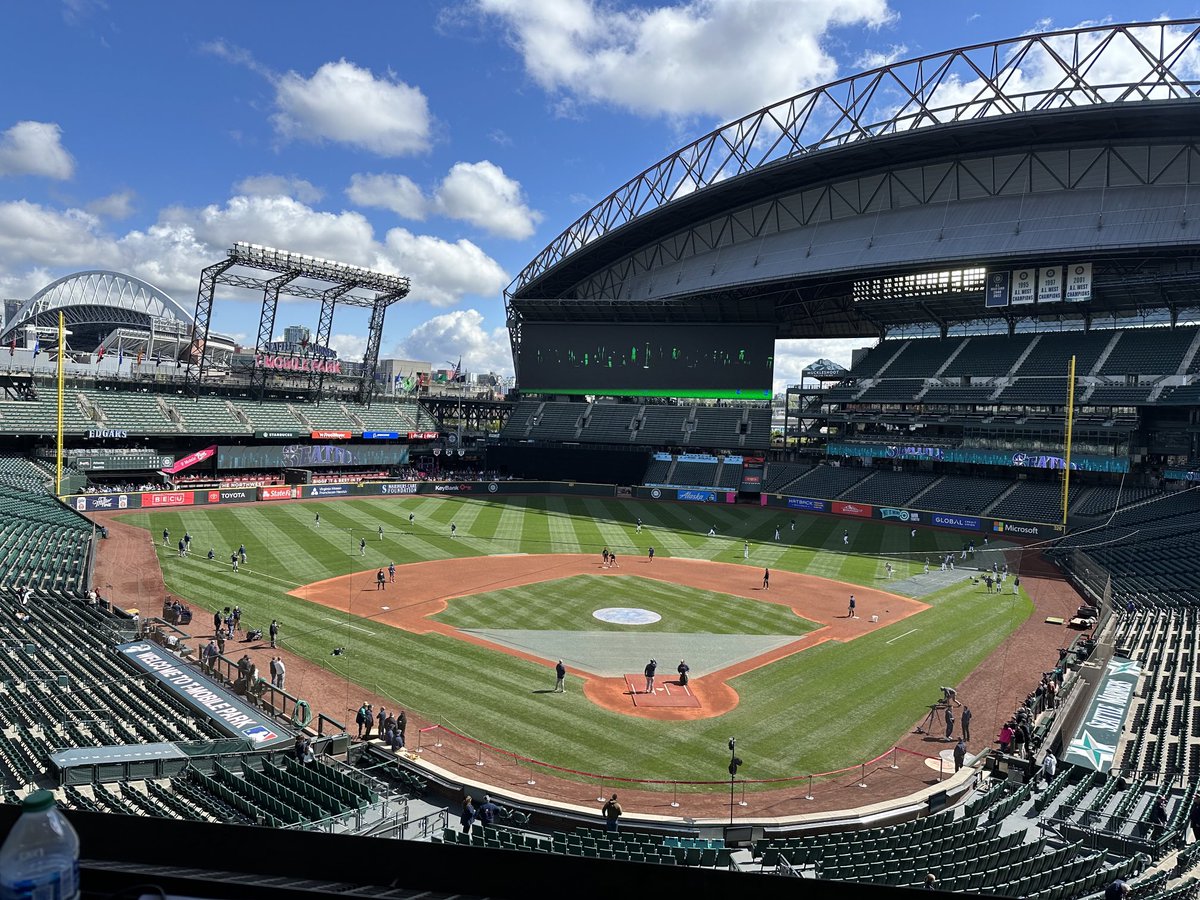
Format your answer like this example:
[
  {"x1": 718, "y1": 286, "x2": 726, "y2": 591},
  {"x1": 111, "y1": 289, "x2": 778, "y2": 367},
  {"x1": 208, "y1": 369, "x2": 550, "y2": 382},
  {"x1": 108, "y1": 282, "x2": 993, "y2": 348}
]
[{"x1": 125, "y1": 496, "x2": 1032, "y2": 779}]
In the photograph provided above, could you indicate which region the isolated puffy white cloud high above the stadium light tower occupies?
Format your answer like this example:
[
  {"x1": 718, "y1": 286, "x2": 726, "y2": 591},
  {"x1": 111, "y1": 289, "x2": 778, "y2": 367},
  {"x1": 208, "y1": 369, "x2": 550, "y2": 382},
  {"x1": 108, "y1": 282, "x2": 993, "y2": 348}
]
[{"x1": 272, "y1": 59, "x2": 432, "y2": 156}]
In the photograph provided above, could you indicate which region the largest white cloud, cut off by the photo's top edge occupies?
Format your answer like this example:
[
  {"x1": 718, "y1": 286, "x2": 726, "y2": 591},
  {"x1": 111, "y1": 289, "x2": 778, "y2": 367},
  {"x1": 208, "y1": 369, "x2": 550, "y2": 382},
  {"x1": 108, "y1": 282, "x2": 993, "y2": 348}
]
[{"x1": 475, "y1": 0, "x2": 894, "y2": 118}]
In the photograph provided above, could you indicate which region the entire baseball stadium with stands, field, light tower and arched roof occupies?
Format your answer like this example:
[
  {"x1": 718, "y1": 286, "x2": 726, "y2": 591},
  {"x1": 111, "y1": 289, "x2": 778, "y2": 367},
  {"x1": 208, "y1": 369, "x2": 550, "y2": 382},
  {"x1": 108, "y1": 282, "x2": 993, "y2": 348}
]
[{"x1": 0, "y1": 20, "x2": 1200, "y2": 900}]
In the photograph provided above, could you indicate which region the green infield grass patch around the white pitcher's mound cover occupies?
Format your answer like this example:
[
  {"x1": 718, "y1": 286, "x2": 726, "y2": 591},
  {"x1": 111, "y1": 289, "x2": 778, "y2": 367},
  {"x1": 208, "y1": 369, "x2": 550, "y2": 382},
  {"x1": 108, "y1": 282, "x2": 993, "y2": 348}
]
[{"x1": 433, "y1": 575, "x2": 817, "y2": 637}]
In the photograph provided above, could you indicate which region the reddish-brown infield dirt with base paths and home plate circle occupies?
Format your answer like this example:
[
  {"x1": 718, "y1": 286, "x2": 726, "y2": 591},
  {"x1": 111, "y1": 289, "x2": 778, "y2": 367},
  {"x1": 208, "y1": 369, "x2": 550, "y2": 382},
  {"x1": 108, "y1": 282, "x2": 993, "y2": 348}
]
[{"x1": 288, "y1": 553, "x2": 929, "y2": 719}]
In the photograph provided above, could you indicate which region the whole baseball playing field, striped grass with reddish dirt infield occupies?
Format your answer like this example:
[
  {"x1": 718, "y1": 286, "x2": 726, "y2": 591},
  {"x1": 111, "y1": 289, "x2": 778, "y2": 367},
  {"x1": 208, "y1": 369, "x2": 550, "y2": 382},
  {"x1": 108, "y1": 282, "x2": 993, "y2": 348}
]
[{"x1": 122, "y1": 496, "x2": 1032, "y2": 779}]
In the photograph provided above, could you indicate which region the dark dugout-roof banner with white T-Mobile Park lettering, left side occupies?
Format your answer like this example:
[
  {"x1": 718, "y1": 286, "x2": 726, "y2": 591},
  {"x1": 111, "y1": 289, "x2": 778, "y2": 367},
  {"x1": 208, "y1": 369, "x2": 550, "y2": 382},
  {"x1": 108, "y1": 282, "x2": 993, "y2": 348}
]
[{"x1": 116, "y1": 641, "x2": 292, "y2": 748}]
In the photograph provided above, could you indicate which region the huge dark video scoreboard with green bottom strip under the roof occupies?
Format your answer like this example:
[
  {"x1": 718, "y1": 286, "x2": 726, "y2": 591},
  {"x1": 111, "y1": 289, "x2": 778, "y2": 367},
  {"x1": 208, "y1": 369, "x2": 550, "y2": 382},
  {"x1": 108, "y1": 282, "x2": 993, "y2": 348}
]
[{"x1": 518, "y1": 322, "x2": 775, "y2": 400}]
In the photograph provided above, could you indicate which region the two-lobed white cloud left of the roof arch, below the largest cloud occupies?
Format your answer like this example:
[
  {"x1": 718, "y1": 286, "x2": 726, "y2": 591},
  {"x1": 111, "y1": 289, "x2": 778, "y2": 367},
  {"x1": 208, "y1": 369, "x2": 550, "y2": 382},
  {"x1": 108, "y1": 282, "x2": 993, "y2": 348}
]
[{"x1": 346, "y1": 160, "x2": 542, "y2": 240}]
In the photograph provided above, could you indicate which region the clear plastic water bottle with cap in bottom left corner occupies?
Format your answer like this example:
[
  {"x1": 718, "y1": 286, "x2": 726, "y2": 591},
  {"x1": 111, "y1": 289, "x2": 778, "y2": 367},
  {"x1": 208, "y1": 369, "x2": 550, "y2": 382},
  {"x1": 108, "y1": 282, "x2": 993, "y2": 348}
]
[{"x1": 0, "y1": 791, "x2": 79, "y2": 900}]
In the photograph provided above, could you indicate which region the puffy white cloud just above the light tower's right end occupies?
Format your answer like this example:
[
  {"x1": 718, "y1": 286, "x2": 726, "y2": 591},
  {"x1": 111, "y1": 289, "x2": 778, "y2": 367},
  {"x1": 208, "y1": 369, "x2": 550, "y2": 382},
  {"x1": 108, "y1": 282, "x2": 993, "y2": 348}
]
[{"x1": 383, "y1": 228, "x2": 509, "y2": 306}]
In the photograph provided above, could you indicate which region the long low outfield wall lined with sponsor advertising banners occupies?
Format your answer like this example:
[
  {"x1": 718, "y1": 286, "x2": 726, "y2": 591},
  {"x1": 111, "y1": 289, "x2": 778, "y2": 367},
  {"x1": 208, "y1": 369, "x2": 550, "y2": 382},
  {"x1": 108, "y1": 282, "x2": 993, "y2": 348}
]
[{"x1": 62, "y1": 481, "x2": 1063, "y2": 541}]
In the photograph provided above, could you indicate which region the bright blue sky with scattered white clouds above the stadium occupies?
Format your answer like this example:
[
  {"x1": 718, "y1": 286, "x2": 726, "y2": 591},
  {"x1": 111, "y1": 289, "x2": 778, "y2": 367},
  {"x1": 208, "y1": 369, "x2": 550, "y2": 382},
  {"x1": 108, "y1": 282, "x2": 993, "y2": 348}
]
[{"x1": 0, "y1": 0, "x2": 1176, "y2": 384}]
